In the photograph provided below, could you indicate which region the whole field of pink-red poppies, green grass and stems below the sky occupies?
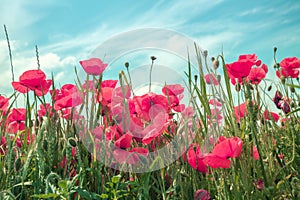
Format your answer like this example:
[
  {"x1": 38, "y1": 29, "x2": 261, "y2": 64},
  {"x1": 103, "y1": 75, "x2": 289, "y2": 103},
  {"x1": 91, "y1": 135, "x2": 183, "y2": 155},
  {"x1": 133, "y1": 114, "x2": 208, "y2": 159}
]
[{"x1": 0, "y1": 35, "x2": 300, "y2": 200}]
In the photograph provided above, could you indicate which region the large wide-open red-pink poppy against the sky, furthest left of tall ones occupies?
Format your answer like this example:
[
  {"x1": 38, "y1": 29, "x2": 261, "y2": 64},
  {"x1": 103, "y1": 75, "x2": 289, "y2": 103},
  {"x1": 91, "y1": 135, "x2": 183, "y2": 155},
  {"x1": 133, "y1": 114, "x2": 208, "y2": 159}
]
[{"x1": 12, "y1": 70, "x2": 52, "y2": 96}]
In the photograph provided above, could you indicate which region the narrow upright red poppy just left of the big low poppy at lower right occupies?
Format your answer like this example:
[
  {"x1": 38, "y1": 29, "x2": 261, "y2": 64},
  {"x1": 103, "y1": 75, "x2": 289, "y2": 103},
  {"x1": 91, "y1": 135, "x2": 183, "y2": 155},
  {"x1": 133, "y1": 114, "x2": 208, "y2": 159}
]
[{"x1": 187, "y1": 143, "x2": 207, "y2": 173}]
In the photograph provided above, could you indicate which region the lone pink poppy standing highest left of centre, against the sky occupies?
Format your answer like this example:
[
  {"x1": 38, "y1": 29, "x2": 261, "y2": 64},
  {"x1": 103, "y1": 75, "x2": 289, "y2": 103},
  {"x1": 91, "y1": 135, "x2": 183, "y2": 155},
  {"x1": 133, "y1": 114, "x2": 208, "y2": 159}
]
[{"x1": 79, "y1": 58, "x2": 108, "y2": 76}]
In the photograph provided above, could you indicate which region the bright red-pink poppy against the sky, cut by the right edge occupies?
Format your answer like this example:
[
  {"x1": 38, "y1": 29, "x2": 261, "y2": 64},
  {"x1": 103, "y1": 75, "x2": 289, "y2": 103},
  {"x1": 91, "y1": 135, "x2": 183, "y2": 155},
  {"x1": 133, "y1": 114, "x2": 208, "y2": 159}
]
[{"x1": 276, "y1": 57, "x2": 300, "y2": 78}]
